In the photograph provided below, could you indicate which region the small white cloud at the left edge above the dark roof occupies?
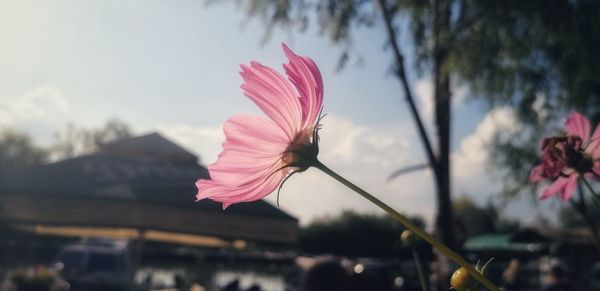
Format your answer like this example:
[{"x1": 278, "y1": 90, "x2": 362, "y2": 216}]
[{"x1": 0, "y1": 86, "x2": 71, "y2": 126}]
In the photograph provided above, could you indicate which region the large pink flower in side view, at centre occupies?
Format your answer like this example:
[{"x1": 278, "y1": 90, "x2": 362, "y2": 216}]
[{"x1": 196, "y1": 44, "x2": 323, "y2": 209}]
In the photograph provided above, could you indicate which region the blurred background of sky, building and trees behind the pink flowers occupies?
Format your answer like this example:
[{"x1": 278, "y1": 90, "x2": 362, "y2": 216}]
[{"x1": 0, "y1": 0, "x2": 600, "y2": 290}]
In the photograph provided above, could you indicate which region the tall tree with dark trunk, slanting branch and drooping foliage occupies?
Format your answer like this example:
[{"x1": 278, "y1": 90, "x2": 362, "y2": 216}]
[{"x1": 224, "y1": 0, "x2": 600, "y2": 251}]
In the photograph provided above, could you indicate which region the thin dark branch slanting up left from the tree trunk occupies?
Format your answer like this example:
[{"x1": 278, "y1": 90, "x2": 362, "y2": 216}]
[{"x1": 377, "y1": 0, "x2": 438, "y2": 172}]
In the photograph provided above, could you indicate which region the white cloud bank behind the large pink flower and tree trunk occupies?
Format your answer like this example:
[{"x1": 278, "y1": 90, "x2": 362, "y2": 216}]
[{"x1": 159, "y1": 108, "x2": 540, "y2": 226}]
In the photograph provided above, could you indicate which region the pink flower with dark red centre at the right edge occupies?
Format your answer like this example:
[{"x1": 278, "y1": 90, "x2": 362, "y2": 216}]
[{"x1": 529, "y1": 112, "x2": 600, "y2": 201}]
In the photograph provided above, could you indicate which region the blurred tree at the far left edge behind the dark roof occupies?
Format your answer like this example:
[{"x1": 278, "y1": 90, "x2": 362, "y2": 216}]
[{"x1": 0, "y1": 129, "x2": 48, "y2": 174}]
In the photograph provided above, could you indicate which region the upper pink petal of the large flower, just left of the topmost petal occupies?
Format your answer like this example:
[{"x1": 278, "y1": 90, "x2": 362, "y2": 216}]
[{"x1": 240, "y1": 62, "x2": 302, "y2": 140}]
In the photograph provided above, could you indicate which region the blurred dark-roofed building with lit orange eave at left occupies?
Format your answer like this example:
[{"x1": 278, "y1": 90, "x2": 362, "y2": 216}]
[{"x1": 0, "y1": 133, "x2": 298, "y2": 247}]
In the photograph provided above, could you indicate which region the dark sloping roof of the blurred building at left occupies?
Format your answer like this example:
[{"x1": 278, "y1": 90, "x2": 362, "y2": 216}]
[{"x1": 0, "y1": 133, "x2": 296, "y2": 221}]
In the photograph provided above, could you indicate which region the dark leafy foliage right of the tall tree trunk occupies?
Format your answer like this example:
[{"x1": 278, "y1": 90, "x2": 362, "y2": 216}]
[{"x1": 440, "y1": 0, "x2": 600, "y2": 201}]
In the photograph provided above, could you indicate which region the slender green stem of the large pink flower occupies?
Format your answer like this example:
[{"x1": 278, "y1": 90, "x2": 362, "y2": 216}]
[{"x1": 313, "y1": 160, "x2": 500, "y2": 291}]
